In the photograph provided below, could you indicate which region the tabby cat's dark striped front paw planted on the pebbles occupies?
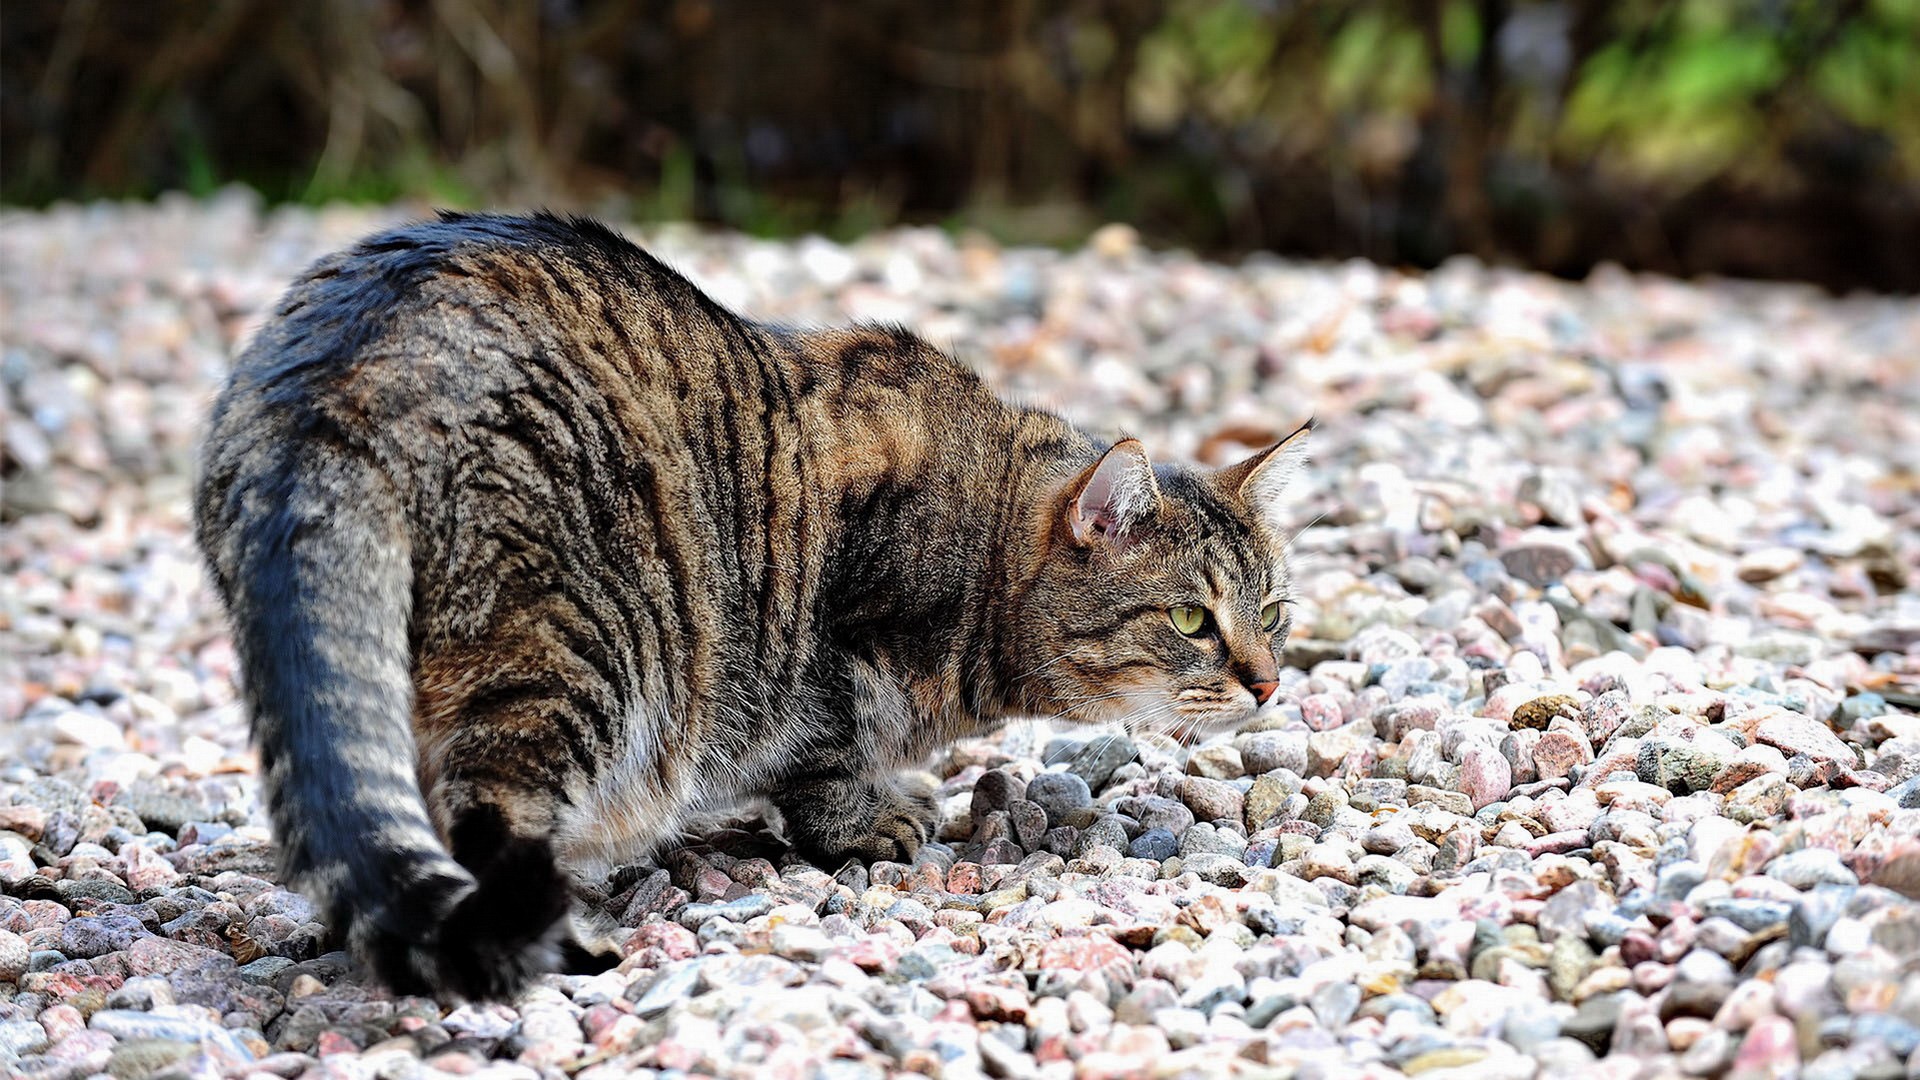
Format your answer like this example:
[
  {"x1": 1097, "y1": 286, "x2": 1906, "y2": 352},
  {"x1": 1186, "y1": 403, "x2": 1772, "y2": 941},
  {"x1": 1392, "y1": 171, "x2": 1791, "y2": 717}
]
[{"x1": 774, "y1": 776, "x2": 937, "y2": 865}]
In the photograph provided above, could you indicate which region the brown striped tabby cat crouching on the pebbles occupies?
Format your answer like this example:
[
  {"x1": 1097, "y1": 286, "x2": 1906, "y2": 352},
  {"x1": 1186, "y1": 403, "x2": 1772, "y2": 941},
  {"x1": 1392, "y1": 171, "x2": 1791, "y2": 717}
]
[{"x1": 194, "y1": 213, "x2": 1311, "y2": 999}]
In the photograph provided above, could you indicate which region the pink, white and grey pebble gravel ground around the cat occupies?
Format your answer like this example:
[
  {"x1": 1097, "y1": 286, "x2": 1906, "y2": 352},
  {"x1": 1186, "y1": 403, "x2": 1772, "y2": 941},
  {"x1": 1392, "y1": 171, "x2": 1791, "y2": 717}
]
[{"x1": 0, "y1": 196, "x2": 1920, "y2": 1080}]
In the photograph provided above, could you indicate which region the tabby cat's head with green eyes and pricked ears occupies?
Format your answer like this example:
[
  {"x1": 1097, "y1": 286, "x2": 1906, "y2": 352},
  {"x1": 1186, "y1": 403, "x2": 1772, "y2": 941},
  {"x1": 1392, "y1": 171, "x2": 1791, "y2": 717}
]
[{"x1": 1014, "y1": 423, "x2": 1311, "y2": 738}]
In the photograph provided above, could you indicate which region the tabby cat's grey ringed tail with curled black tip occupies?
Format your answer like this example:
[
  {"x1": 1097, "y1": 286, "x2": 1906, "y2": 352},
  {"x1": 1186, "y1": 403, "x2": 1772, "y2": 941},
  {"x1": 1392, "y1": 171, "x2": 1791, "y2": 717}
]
[{"x1": 196, "y1": 441, "x2": 570, "y2": 999}]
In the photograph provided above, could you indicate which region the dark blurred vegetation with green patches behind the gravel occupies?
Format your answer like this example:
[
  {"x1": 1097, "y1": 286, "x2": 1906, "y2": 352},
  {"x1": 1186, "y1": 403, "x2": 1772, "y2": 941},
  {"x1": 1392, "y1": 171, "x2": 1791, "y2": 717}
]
[{"x1": 0, "y1": 0, "x2": 1920, "y2": 290}]
